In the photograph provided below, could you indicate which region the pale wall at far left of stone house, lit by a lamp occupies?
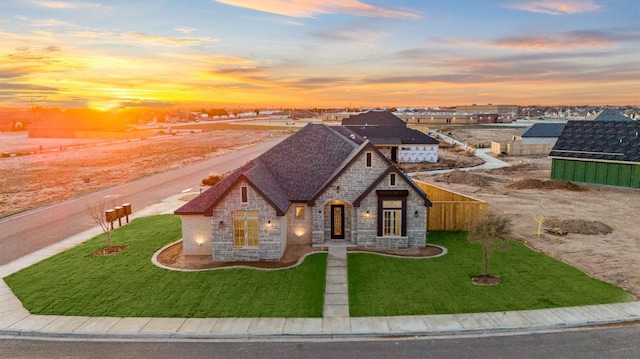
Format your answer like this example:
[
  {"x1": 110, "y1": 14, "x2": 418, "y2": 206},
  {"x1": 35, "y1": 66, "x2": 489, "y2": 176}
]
[{"x1": 180, "y1": 215, "x2": 213, "y2": 256}]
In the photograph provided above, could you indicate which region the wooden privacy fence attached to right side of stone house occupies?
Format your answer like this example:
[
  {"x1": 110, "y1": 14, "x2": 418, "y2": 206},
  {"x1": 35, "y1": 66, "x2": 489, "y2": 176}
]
[{"x1": 414, "y1": 180, "x2": 489, "y2": 231}]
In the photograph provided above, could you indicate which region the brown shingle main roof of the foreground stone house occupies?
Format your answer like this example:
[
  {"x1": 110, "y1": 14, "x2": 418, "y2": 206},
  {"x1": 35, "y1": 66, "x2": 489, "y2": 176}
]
[{"x1": 174, "y1": 123, "x2": 358, "y2": 215}]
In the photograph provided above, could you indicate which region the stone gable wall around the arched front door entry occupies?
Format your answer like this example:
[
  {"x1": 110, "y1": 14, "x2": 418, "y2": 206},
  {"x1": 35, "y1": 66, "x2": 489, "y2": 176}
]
[{"x1": 313, "y1": 150, "x2": 388, "y2": 244}]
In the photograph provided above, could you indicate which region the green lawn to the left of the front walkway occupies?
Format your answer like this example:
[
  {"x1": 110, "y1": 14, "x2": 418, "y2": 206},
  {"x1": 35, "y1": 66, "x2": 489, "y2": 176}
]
[{"x1": 5, "y1": 215, "x2": 327, "y2": 318}]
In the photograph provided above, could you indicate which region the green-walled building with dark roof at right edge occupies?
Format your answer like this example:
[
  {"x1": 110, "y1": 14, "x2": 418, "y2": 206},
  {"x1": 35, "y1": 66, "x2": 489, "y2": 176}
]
[{"x1": 549, "y1": 120, "x2": 640, "y2": 188}]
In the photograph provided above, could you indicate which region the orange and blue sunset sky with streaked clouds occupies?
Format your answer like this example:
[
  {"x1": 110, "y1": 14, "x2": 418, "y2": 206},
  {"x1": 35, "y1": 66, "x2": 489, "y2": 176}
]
[{"x1": 0, "y1": 0, "x2": 640, "y2": 110}]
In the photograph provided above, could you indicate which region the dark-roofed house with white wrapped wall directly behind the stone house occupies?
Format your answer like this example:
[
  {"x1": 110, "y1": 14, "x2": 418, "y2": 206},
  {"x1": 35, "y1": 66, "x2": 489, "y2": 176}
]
[{"x1": 342, "y1": 111, "x2": 439, "y2": 163}]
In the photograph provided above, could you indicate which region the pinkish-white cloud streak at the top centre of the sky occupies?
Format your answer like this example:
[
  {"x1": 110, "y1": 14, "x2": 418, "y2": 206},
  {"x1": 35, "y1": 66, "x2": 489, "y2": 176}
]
[{"x1": 216, "y1": 0, "x2": 422, "y2": 19}]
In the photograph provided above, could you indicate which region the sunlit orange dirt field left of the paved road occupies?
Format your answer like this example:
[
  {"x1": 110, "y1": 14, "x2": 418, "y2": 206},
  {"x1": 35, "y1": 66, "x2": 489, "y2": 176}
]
[{"x1": 0, "y1": 130, "x2": 287, "y2": 216}]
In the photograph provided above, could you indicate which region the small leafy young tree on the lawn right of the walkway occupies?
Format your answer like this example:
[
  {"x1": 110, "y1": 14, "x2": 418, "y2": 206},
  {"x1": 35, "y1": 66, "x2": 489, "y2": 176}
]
[{"x1": 467, "y1": 212, "x2": 513, "y2": 277}]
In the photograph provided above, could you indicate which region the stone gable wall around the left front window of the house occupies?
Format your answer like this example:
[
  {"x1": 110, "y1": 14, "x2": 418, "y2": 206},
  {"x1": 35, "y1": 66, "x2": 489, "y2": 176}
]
[{"x1": 211, "y1": 181, "x2": 287, "y2": 262}]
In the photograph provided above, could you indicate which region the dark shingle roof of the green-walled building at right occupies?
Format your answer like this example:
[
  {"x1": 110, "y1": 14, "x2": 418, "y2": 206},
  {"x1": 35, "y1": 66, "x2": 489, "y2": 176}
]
[{"x1": 549, "y1": 121, "x2": 640, "y2": 163}]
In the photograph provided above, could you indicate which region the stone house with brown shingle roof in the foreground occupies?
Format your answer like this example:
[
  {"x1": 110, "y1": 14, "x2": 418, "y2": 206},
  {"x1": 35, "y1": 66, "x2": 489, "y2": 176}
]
[{"x1": 174, "y1": 123, "x2": 431, "y2": 261}]
